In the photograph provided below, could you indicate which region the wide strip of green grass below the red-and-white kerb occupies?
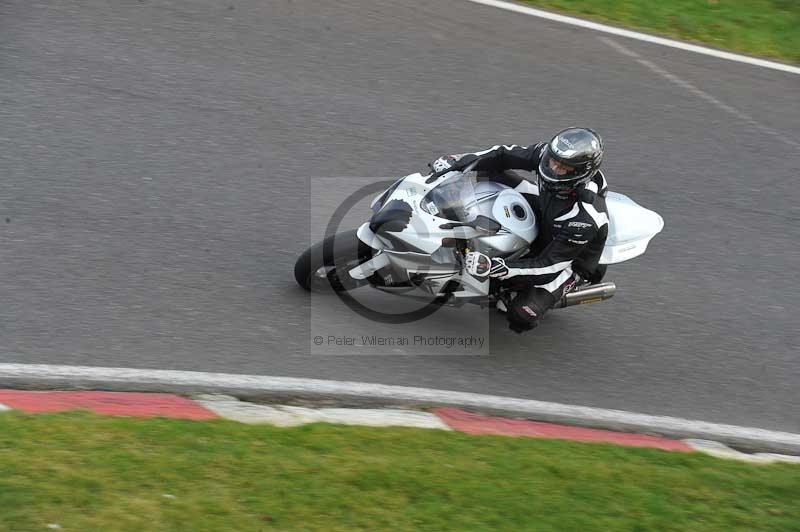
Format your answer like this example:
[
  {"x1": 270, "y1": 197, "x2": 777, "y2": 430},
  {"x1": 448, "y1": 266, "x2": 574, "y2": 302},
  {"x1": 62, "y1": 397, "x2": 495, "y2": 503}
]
[{"x1": 0, "y1": 412, "x2": 800, "y2": 532}]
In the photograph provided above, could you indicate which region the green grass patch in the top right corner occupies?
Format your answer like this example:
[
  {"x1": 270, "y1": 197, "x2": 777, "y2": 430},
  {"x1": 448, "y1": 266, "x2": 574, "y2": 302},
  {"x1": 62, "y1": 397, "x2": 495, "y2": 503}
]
[{"x1": 527, "y1": 0, "x2": 800, "y2": 63}]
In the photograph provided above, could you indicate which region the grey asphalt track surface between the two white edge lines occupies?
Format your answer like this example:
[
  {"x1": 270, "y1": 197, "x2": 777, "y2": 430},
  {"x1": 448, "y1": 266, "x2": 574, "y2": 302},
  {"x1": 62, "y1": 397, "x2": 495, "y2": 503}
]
[{"x1": 0, "y1": 0, "x2": 800, "y2": 431}]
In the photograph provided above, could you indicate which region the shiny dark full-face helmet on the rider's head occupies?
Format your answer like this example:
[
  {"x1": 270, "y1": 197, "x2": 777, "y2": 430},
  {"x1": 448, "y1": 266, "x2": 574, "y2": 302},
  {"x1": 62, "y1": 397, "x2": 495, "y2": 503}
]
[{"x1": 539, "y1": 127, "x2": 603, "y2": 191}]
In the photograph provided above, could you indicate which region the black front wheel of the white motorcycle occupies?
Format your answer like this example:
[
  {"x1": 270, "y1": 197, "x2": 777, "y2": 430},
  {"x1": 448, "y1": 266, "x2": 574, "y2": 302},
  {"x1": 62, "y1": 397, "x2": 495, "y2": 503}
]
[{"x1": 294, "y1": 229, "x2": 372, "y2": 292}]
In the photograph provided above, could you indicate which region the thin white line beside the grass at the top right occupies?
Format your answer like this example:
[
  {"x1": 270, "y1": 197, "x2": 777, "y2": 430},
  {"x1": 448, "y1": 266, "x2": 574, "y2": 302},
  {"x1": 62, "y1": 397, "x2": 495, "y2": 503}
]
[{"x1": 468, "y1": 0, "x2": 800, "y2": 74}]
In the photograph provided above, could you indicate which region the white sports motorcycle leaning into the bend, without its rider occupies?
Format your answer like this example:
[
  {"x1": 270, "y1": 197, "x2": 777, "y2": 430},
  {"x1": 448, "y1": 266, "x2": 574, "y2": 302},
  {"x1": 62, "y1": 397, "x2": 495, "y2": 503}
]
[{"x1": 294, "y1": 162, "x2": 664, "y2": 318}]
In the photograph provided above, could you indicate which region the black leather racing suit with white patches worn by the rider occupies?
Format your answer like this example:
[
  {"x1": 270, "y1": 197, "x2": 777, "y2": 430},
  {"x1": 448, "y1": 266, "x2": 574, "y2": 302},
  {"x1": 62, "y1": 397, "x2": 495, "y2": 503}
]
[{"x1": 446, "y1": 143, "x2": 608, "y2": 332}]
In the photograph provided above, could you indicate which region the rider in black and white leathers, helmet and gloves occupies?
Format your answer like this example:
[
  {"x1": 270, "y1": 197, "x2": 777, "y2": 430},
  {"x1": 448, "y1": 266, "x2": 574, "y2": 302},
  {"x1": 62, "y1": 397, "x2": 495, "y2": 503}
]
[{"x1": 430, "y1": 127, "x2": 608, "y2": 333}]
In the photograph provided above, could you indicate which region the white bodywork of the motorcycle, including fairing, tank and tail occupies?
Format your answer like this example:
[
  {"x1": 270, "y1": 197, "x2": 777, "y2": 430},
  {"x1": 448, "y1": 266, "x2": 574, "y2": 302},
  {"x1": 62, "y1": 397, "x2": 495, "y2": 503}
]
[{"x1": 349, "y1": 172, "x2": 664, "y2": 301}]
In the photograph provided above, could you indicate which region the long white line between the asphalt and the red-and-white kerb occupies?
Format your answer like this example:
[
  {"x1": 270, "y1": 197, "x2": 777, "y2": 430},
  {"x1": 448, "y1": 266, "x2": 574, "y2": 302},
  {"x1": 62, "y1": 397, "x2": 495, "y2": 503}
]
[{"x1": 0, "y1": 364, "x2": 800, "y2": 454}]
